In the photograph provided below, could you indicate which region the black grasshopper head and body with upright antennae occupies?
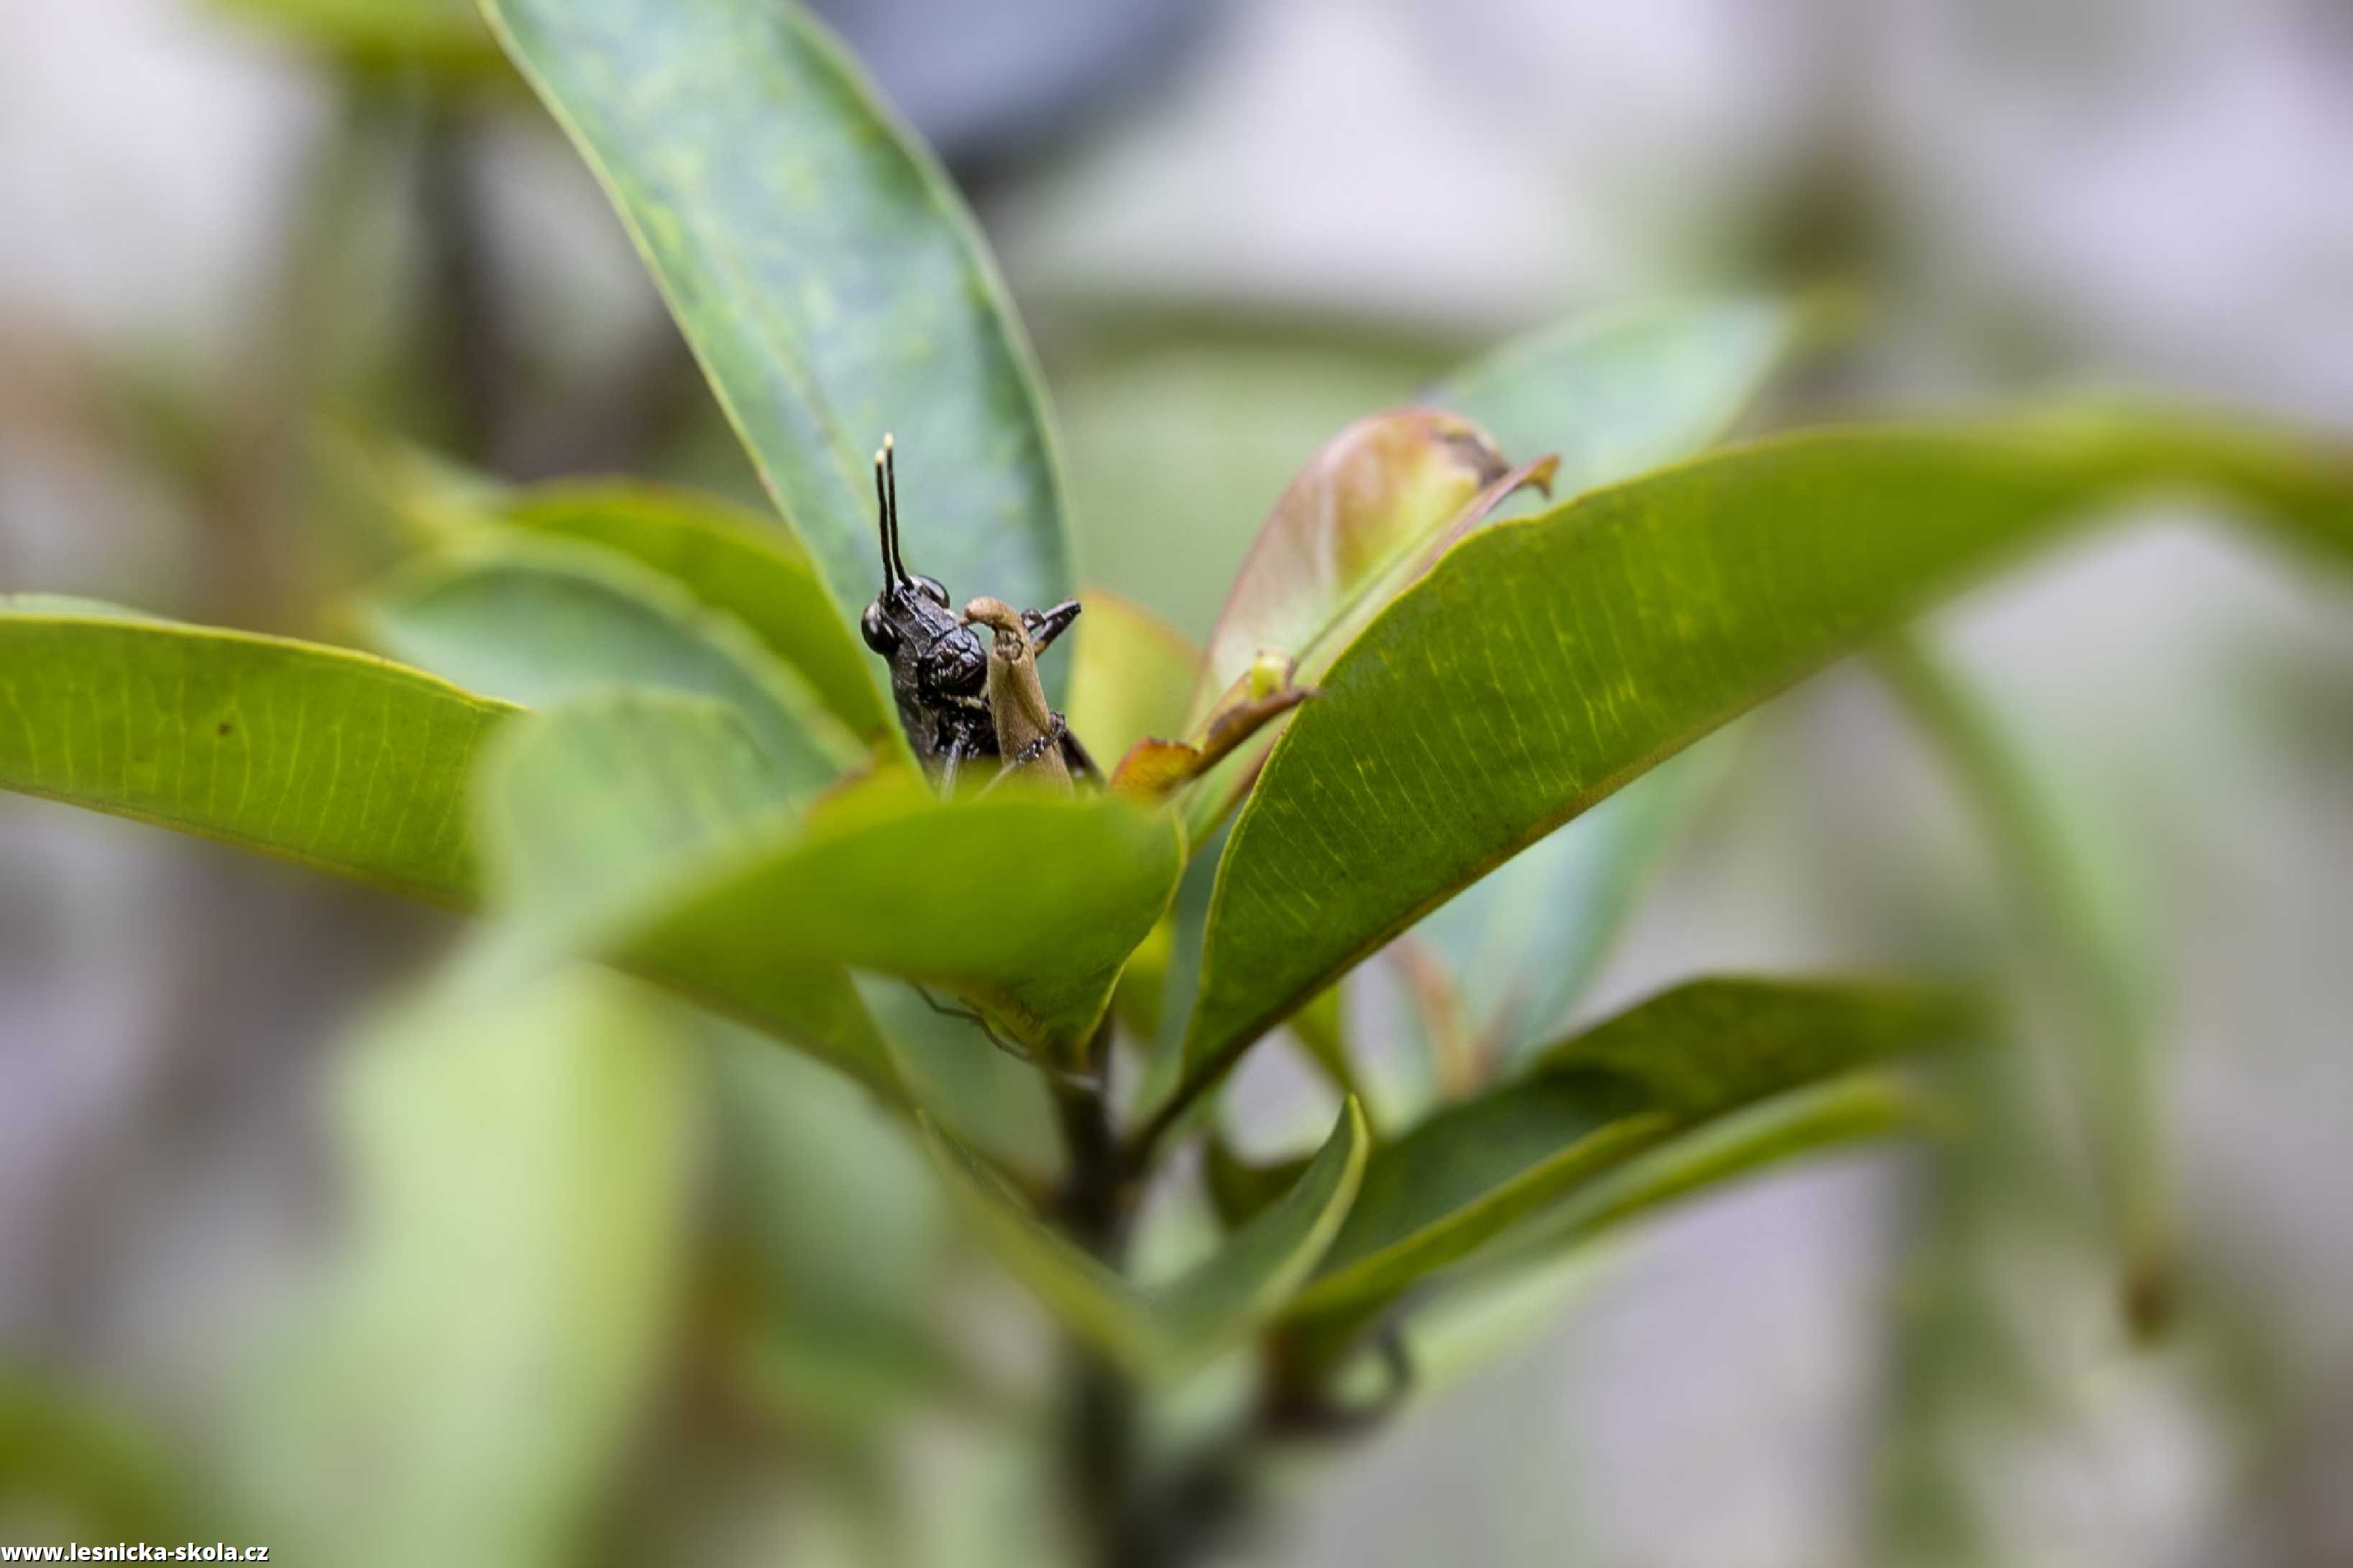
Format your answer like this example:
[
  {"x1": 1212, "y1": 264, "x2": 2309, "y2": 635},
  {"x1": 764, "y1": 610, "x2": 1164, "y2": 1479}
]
[{"x1": 859, "y1": 436, "x2": 1096, "y2": 791}]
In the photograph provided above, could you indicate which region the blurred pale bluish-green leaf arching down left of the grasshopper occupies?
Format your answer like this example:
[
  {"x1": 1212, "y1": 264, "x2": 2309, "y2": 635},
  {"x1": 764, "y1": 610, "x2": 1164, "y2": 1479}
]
[{"x1": 364, "y1": 539, "x2": 863, "y2": 796}]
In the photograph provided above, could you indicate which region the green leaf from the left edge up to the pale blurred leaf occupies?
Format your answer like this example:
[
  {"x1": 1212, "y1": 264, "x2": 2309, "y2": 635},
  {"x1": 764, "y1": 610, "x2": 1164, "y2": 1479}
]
[{"x1": 0, "y1": 612, "x2": 513, "y2": 904}]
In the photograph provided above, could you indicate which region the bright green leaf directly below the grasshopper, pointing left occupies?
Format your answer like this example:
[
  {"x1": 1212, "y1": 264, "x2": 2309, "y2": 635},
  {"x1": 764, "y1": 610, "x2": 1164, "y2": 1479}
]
[{"x1": 633, "y1": 774, "x2": 1181, "y2": 1062}]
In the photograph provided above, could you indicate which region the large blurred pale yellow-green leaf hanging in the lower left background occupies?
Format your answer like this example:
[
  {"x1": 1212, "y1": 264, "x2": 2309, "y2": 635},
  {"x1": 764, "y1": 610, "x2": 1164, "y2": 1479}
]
[{"x1": 231, "y1": 972, "x2": 699, "y2": 1568}]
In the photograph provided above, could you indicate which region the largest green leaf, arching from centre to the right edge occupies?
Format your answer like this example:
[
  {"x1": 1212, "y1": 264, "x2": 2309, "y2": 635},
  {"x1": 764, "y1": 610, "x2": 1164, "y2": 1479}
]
[{"x1": 1188, "y1": 414, "x2": 2353, "y2": 1090}]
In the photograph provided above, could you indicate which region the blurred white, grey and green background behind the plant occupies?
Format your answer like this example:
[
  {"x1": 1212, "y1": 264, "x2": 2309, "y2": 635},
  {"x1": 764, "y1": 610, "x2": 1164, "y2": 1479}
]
[{"x1": 0, "y1": 0, "x2": 2353, "y2": 1568}]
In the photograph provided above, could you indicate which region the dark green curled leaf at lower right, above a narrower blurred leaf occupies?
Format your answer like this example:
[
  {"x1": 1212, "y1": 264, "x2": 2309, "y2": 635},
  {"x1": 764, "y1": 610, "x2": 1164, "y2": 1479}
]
[{"x1": 1290, "y1": 979, "x2": 1974, "y2": 1316}]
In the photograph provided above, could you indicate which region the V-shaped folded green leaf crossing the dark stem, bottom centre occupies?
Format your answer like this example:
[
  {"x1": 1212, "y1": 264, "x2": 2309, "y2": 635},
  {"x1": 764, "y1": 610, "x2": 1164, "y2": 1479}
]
[{"x1": 912, "y1": 1099, "x2": 1370, "y2": 1377}]
